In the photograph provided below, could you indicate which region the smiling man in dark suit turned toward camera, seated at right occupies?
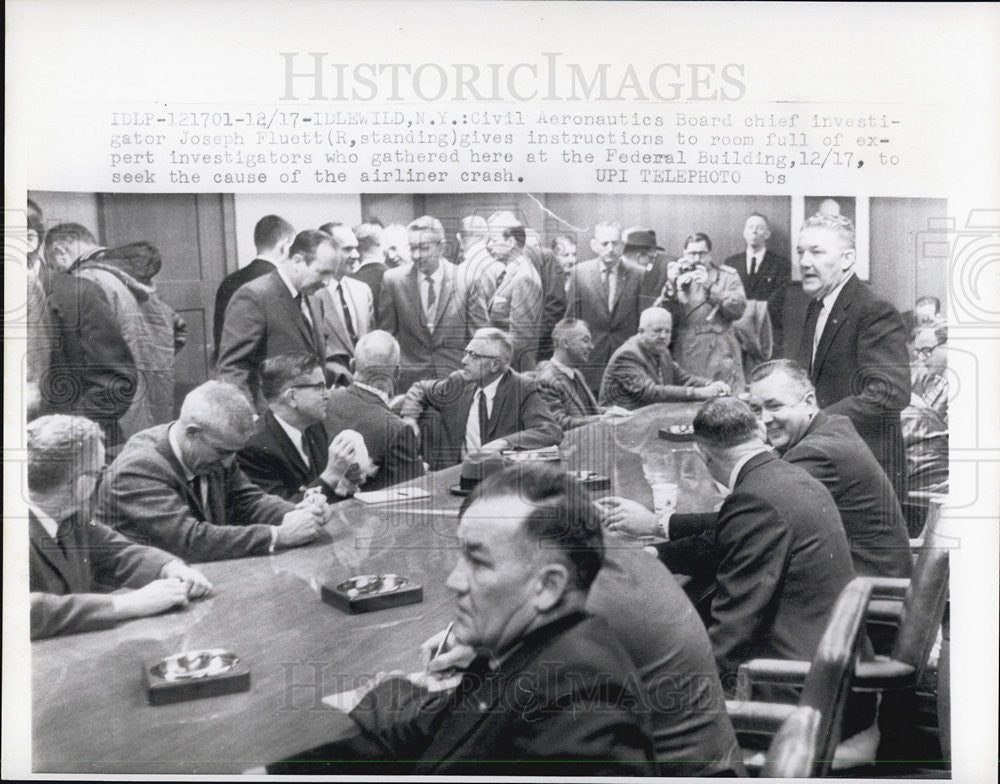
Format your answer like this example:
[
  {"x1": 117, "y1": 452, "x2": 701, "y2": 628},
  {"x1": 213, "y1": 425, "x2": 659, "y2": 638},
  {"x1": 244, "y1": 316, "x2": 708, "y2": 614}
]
[{"x1": 750, "y1": 359, "x2": 913, "y2": 577}]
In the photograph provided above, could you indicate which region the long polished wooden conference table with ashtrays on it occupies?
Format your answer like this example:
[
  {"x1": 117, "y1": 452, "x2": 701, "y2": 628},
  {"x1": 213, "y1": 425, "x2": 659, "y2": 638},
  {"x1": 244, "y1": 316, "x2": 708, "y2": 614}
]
[{"x1": 31, "y1": 404, "x2": 721, "y2": 774}]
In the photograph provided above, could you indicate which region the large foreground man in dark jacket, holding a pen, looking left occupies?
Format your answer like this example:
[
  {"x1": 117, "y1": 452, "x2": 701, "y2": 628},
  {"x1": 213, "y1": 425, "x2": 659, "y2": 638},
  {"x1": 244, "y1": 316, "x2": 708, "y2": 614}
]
[{"x1": 268, "y1": 468, "x2": 653, "y2": 776}]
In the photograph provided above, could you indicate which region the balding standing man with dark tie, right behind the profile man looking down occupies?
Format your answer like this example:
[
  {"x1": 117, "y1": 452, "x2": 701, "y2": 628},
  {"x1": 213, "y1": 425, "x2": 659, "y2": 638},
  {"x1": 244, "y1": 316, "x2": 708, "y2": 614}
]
[{"x1": 316, "y1": 226, "x2": 375, "y2": 383}]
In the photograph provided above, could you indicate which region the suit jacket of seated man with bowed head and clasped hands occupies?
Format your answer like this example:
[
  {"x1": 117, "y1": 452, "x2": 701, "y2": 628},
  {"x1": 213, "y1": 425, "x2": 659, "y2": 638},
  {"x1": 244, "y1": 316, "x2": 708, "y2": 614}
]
[{"x1": 97, "y1": 422, "x2": 293, "y2": 561}]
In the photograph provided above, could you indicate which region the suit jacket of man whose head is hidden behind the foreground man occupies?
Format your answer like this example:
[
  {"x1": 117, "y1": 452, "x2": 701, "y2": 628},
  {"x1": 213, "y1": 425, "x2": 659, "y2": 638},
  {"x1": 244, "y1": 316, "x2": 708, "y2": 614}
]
[{"x1": 587, "y1": 536, "x2": 746, "y2": 776}]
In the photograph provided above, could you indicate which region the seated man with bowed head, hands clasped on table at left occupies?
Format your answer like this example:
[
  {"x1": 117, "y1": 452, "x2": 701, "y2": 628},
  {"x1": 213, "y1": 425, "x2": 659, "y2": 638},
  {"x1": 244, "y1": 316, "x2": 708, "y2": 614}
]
[{"x1": 97, "y1": 381, "x2": 332, "y2": 561}]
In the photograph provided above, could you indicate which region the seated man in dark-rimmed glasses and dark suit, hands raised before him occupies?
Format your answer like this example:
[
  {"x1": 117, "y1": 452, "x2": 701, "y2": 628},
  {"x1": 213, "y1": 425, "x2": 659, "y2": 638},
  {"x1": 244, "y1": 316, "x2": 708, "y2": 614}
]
[{"x1": 236, "y1": 353, "x2": 362, "y2": 503}]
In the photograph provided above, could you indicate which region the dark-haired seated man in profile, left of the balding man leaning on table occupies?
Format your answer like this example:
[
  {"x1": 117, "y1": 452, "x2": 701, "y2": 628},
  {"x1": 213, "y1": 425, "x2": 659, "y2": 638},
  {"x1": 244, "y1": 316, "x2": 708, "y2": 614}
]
[{"x1": 535, "y1": 318, "x2": 628, "y2": 430}]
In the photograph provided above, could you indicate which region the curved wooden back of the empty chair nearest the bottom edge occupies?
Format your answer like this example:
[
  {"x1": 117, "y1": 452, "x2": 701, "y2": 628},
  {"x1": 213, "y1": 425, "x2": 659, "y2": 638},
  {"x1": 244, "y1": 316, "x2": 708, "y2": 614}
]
[{"x1": 761, "y1": 577, "x2": 872, "y2": 778}]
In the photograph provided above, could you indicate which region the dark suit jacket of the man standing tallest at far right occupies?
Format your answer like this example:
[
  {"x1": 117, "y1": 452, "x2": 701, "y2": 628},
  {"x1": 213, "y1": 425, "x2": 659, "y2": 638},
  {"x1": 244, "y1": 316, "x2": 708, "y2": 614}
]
[{"x1": 785, "y1": 275, "x2": 910, "y2": 490}]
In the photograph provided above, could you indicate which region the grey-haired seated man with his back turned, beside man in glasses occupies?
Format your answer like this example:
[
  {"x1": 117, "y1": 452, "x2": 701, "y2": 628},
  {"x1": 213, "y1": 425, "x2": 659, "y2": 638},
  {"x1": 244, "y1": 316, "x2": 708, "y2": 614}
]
[{"x1": 326, "y1": 330, "x2": 424, "y2": 490}]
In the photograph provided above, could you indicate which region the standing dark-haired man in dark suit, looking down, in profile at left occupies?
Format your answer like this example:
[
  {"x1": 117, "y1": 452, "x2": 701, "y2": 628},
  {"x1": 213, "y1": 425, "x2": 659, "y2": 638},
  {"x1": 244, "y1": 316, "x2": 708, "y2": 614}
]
[{"x1": 216, "y1": 231, "x2": 337, "y2": 412}]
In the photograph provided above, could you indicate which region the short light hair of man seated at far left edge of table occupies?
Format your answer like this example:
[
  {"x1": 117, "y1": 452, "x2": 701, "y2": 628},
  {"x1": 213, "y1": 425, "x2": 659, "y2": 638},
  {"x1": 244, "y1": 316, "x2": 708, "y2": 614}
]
[{"x1": 28, "y1": 414, "x2": 104, "y2": 493}]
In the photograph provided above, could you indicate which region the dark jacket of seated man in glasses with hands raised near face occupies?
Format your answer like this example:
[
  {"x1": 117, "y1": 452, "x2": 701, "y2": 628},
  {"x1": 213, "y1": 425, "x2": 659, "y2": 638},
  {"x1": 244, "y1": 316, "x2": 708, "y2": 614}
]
[{"x1": 237, "y1": 409, "x2": 330, "y2": 503}]
